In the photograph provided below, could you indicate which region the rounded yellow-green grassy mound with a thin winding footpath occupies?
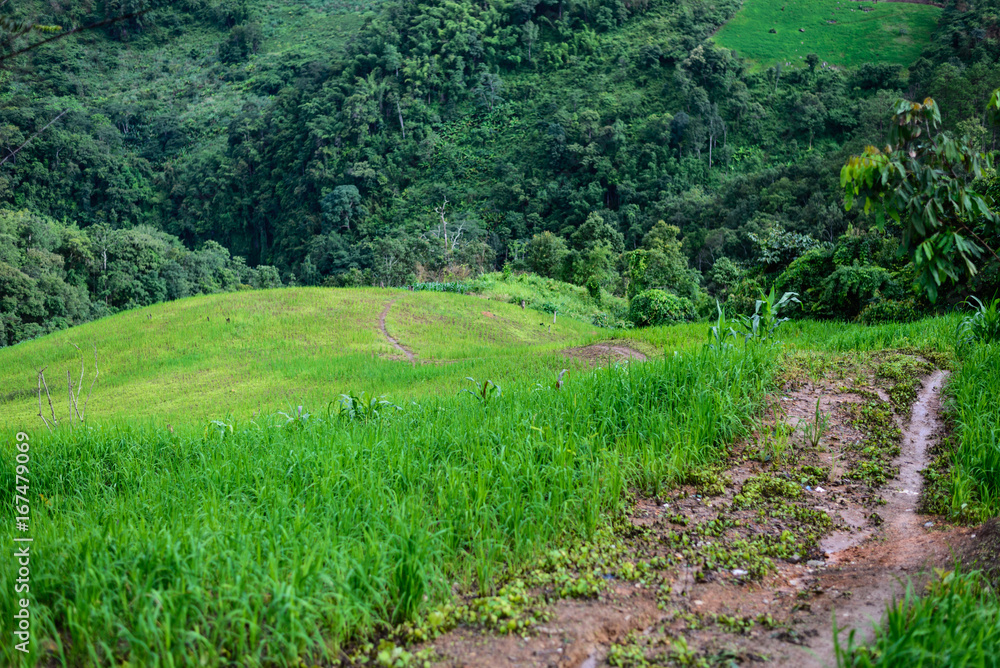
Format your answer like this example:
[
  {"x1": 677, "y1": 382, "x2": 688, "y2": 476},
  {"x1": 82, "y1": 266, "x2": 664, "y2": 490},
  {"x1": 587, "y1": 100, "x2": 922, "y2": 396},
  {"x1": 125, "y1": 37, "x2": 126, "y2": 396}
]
[{"x1": 0, "y1": 288, "x2": 608, "y2": 426}]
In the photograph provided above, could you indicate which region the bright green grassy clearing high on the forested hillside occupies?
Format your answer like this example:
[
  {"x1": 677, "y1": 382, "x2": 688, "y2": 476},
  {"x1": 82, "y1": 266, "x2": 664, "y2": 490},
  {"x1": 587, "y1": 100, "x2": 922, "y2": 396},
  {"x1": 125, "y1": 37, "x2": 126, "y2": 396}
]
[{"x1": 714, "y1": 0, "x2": 941, "y2": 68}]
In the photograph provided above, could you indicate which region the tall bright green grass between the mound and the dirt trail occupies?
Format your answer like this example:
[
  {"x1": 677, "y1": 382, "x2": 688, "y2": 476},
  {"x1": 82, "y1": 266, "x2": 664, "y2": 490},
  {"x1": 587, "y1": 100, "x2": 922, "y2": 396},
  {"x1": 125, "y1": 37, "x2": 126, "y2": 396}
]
[{"x1": 0, "y1": 348, "x2": 775, "y2": 666}]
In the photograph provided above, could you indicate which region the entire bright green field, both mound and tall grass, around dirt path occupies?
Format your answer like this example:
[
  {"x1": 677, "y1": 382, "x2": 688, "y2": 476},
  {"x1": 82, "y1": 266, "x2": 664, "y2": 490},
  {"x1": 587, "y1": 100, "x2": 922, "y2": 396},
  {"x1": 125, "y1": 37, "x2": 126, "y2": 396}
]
[{"x1": 0, "y1": 288, "x2": 1000, "y2": 666}]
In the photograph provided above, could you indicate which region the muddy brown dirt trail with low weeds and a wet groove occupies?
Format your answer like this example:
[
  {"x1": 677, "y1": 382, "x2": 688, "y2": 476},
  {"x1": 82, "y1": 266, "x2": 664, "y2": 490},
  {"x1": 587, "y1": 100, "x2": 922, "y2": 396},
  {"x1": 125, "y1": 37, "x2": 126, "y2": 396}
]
[{"x1": 432, "y1": 351, "x2": 969, "y2": 668}]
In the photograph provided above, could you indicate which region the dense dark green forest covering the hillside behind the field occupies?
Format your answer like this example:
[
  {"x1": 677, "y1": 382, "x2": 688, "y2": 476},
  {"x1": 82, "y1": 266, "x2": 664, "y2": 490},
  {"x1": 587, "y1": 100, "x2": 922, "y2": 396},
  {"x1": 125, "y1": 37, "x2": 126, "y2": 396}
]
[{"x1": 0, "y1": 0, "x2": 1000, "y2": 344}]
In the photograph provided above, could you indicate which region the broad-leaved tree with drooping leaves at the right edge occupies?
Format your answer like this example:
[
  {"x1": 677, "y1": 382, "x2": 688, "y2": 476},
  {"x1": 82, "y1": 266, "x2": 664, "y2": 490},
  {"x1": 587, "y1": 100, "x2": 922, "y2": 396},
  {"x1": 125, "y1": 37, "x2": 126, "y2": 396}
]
[{"x1": 840, "y1": 95, "x2": 1000, "y2": 302}]
